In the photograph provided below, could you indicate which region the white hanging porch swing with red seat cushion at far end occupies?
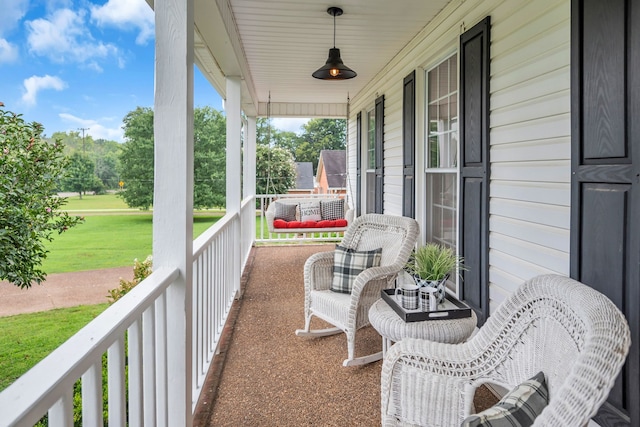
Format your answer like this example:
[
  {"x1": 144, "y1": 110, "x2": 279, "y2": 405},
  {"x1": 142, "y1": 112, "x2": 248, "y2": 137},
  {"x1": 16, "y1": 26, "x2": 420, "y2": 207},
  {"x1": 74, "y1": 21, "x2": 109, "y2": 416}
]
[{"x1": 265, "y1": 196, "x2": 354, "y2": 233}]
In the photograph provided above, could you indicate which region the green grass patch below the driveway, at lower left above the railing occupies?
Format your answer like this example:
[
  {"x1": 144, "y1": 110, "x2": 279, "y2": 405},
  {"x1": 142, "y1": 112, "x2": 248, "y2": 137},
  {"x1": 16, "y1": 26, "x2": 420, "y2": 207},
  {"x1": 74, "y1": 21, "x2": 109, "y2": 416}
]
[{"x1": 0, "y1": 304, "x2": 108, "y2": 390}]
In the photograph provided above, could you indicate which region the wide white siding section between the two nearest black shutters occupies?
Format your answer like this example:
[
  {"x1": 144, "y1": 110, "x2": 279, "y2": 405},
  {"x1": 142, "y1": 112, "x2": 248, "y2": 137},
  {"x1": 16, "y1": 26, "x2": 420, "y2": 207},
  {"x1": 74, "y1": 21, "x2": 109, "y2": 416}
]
[{"x1": 489, "y1": 0, "x2": 571, "y2": 311}]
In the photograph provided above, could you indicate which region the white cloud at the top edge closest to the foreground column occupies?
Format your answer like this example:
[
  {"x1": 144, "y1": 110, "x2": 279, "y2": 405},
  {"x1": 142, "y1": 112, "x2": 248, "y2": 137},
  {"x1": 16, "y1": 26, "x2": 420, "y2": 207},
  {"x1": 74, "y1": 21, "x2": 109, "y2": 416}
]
[{"x1": 91, "y1": 0, "x2": 155, "y2": 45}]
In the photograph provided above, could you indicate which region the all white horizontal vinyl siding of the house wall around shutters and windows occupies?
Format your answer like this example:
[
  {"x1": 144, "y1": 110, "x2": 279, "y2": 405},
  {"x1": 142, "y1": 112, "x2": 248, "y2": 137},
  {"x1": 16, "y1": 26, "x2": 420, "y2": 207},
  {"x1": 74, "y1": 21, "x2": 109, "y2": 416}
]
[{"x1": 350, "y1": 0, "x2": 571, "y2": 311}]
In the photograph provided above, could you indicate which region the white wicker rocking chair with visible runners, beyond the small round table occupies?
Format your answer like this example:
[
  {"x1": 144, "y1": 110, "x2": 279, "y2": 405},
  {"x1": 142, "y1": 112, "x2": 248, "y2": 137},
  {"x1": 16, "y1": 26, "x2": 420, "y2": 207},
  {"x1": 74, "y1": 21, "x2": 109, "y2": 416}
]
[{"x1": 296, "y1": 214, "x2": 419, "y2": 366}]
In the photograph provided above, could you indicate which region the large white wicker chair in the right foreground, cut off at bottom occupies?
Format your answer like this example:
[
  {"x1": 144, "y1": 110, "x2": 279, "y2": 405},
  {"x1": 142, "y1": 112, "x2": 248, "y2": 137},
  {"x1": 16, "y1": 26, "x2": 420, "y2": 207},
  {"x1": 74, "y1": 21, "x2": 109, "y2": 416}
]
[{"x1": 381, "y1": 275, "x2": 631, "y2": 427}]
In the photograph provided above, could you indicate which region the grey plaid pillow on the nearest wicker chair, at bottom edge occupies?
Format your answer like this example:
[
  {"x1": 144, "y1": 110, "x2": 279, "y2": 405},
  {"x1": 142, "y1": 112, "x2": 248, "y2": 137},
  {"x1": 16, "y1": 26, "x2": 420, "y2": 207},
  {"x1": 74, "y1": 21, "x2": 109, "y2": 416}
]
[{"x1": 461, "y1": 372, "x2": 549, "y2": 427}]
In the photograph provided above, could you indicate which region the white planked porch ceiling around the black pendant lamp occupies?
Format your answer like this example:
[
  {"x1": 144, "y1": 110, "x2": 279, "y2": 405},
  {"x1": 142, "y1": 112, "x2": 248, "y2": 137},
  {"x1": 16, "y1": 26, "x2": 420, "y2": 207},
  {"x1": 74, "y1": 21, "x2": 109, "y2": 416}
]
[{"x1": 190, "y1": 0, "x2": 451, "y2": 117}]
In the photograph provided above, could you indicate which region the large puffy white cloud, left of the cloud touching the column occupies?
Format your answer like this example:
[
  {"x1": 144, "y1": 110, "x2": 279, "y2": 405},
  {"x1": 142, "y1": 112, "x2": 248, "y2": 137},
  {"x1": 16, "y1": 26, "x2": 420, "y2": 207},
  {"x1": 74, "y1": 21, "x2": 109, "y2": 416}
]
[{"x1": 25, "y1": 9, "x2": 119, "y2": 66}]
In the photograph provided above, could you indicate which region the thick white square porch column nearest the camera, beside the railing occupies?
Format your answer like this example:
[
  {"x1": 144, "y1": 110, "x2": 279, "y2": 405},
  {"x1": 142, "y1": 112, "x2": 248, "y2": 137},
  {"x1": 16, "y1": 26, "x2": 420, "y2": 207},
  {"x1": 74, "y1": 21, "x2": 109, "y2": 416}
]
[{"x1": 153, "y1": 0, "x2": 194, "y2": 426}]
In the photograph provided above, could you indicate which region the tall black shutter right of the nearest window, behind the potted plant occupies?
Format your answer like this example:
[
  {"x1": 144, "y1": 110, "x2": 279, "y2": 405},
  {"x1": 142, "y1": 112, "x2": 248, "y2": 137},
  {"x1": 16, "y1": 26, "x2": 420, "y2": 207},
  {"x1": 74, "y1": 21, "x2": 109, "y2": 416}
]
[{"x1": 459, "y1": 17, "x2": 491, "y2": 325}]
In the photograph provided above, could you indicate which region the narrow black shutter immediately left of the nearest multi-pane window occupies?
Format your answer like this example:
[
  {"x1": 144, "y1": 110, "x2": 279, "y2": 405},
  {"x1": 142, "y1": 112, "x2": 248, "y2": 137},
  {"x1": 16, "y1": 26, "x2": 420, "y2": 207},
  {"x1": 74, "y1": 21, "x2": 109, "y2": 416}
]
[{"x1": 402, "y1": 70, "x2": 416, "y2": 218}]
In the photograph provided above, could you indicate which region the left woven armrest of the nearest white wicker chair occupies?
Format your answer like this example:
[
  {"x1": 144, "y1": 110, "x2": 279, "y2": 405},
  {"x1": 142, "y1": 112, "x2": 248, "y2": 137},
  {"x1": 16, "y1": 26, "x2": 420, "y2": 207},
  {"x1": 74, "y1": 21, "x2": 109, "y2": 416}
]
[{"x1": 381, "y1": 339, "x2": 482, "y2": 426}]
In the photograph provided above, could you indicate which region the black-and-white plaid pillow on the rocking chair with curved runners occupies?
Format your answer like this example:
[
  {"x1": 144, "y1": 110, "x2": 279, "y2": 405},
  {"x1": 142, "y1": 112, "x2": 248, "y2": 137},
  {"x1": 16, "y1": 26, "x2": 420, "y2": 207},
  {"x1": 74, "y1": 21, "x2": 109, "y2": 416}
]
[{"x1": 331, "y1": 245, "x2": 382, "y2": 294}]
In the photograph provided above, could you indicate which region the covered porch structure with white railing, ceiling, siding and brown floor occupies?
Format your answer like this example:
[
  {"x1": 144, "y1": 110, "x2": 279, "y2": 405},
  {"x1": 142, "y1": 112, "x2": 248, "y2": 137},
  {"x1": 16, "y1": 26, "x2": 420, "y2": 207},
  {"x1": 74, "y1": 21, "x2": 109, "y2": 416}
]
[{"x1": 0, "y1": 0, "x2": 640, "y2": 427}]
